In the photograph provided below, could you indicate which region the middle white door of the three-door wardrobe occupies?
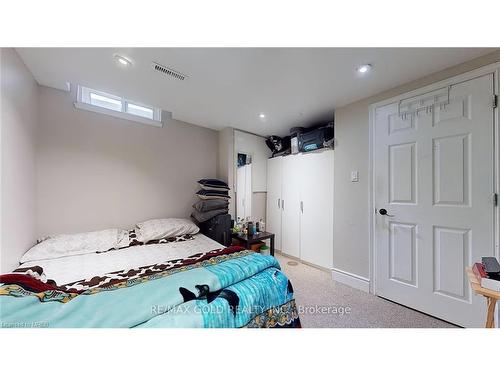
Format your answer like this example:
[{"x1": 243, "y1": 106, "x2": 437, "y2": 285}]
[{"x1": 281, "y1": 155, "x2": 302, "y2": 258}]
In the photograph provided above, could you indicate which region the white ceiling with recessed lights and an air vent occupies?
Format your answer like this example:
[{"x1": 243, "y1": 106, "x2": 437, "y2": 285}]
[{"x1": 17, "y1": 48, "x2": 493, "y2": 135}]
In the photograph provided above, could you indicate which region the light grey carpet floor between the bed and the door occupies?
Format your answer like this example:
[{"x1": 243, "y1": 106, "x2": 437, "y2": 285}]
[{"x1": 276, "y1": 254, "x2": 455, "y2": 328}]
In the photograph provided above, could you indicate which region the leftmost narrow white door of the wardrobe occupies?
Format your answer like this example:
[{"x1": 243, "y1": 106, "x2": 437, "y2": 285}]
[{"x1": 266, "y1": 156, "x2": 283, "y2": 250}]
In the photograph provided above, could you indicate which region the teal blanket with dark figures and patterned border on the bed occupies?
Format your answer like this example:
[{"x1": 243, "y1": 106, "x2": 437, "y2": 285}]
[{"x1": 0, "y1": 251, "x2": 298, "y2": 328}]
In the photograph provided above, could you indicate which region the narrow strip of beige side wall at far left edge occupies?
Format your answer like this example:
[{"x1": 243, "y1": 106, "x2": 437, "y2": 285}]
[{"x1": 0, "y1": 48, "x2": 38, "y2": 273}]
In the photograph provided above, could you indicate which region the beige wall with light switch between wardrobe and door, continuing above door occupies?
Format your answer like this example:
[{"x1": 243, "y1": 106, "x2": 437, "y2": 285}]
[{"x1": 333, "y1": 51, "x2": 500, "y2": 278}]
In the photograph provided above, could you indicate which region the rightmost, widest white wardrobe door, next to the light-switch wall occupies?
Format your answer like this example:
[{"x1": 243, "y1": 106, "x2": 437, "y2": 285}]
[{"x1": 300, "y1": 151, "x2": 333, "y2": 269}]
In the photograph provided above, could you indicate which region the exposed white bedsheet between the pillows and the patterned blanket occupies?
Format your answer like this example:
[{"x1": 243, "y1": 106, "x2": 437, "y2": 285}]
[{"x1": 21, "y1": 234, "x2": 225, "y2": 285}]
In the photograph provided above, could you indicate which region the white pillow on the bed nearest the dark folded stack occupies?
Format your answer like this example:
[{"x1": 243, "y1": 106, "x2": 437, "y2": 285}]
[{"x1": 136, "y1": 219, "x2": 200, "y2": 243}]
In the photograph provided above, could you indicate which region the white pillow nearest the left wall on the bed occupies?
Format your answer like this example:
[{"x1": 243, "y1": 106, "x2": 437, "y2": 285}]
[{"x1": 21, "y1": 229, "x2": 128, "y2": 263}]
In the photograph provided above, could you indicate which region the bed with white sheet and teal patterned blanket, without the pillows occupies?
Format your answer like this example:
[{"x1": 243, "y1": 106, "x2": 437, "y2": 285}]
[{"x1": 0, "y1": 234, "x2": 300, "y2": 328}]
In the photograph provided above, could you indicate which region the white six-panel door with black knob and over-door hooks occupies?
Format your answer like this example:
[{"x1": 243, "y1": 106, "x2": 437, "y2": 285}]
[{"x1": 375, "y1": 74, "x2": 494, "y2": 327}]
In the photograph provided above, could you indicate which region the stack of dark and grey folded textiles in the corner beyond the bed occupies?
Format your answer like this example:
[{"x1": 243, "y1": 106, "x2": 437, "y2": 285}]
[{"x1": 191, "y1": 178, "x2": 230, "y2": 223}]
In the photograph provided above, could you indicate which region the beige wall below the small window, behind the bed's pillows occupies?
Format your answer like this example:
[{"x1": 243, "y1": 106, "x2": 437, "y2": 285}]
[{"x1": 36, "y1": 87, "x2": 218, "y2": 235}]
